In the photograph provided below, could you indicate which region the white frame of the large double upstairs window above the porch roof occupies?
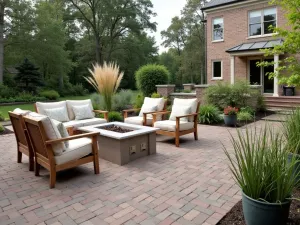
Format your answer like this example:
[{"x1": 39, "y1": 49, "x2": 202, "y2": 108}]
[{"x1": 248, "y1": 7, "x2": 278, "y2": 38}]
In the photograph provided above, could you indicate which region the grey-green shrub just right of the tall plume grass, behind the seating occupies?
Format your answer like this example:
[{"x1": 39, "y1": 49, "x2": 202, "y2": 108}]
[{"x1": 113, "y1": 90, "x2": 134, "y2": 111}]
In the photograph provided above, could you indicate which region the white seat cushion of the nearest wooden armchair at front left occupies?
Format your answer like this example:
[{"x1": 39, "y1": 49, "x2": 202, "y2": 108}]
[{"x1": 54, "y1": 138, "x2": 92, "y2": 165}]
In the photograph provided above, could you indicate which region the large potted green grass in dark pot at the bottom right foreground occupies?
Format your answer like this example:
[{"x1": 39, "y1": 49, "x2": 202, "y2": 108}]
[{"x1": 224, "y1": 127, "x2": 298, "y2": 225}]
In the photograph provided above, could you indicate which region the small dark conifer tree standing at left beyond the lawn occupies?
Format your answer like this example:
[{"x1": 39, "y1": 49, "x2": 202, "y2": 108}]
[{"x1": 15, "y1": 59, "x2": 43, "y2": 92}]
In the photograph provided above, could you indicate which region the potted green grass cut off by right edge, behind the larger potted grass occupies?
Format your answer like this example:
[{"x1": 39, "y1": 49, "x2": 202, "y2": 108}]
[{"x1": 282, "y1": 108, "x2": 300, "y2": 181}]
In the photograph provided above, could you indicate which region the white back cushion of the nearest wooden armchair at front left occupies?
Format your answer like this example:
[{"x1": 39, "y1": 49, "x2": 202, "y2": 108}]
[{"x1": 28, "y1": 113, "x2": 65, "y2": 156}]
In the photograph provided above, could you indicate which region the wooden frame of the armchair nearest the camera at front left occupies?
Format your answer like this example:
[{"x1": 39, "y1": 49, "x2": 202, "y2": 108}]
[{"x1": 24, "y1": 116, "x2": 100, "y2": 188}]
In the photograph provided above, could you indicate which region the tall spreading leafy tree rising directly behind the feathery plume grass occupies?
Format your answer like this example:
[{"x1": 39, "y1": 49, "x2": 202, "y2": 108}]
[{"x1": 66, "y1": 0, "x2": 156, "y2": 64}]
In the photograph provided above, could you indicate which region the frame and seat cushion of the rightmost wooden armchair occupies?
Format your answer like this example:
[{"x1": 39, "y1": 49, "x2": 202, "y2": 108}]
[{"x1": 152, "y1": 99, "x2": 200, "y2": 147}]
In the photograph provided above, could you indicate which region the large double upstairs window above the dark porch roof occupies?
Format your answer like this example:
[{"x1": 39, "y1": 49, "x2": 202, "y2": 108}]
[{"x1": 249, "y1": 8, "x2": 277, "y2": 36}]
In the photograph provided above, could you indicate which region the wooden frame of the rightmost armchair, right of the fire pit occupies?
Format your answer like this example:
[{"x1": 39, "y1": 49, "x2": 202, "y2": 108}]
[{"x1": 152, "y1": 102, "x2": 200, "y2": 147}]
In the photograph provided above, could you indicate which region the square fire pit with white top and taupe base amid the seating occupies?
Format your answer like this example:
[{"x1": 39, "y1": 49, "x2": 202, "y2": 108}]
[{"x1": 78, "y1": 122, "x2": 158, "y2": 166}]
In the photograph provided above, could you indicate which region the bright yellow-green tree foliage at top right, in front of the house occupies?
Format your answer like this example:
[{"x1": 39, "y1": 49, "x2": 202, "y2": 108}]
[{"x1": 259, "y1": 0, "x2": 300, "y2": 86}]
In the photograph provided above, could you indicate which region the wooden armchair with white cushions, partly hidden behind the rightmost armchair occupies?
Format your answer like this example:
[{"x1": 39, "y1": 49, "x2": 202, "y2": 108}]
[{"x1": 123, "y1": 97, "x2": 167, "y2": 126}]
